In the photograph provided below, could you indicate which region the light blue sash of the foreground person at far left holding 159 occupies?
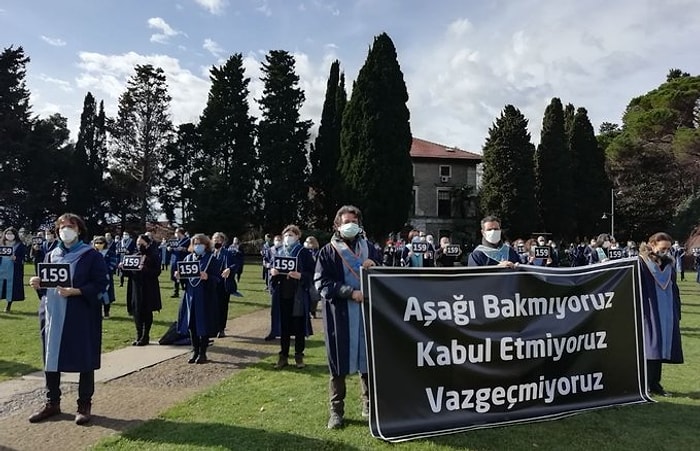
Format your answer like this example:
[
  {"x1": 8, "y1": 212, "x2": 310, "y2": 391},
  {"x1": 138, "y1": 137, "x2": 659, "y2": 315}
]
[{"x1": 44, "y1": 241, "x2": 93, "y2": 371}]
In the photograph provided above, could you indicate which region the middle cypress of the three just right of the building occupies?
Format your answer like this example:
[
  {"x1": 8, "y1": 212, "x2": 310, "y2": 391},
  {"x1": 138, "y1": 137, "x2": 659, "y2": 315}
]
[{"x1": 535, "y1": 97, "x2": 576, "y2": 238}]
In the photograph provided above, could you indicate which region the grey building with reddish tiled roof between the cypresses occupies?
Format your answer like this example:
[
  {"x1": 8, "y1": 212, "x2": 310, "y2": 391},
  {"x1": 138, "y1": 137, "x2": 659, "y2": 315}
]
[{"x1": 408, "y1": 138, "x2": 482, "y2": 243}]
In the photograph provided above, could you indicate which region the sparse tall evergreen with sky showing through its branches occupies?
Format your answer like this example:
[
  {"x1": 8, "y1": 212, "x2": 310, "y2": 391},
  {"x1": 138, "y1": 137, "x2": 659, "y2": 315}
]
[{"x1": 111, "y1": 64, "x2": 173, "y2": 229}]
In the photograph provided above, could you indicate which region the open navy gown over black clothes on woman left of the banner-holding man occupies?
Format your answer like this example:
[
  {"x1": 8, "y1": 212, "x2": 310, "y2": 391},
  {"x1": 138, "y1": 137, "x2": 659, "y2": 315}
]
[{"x1": 270, "y1": 243, "x2": 315, "y2": 337}]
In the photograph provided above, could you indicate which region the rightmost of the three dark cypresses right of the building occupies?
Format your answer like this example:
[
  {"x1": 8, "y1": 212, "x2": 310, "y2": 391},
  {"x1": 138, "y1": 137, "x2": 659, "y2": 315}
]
[{"x1": 569, "y1": 108, "x2": 610, "y2": 239}]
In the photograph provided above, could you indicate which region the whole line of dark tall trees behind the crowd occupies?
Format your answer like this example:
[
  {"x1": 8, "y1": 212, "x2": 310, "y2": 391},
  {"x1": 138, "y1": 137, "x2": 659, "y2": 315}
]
[{"x1": 0, "y1": 33, "x2": 700, "y2": 244}]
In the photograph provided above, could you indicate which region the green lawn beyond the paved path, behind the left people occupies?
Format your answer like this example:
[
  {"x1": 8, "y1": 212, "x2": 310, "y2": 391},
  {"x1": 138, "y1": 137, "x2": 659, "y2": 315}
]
[{"x1": 0, "y1": 264, "x2": 270, "y2": 381}]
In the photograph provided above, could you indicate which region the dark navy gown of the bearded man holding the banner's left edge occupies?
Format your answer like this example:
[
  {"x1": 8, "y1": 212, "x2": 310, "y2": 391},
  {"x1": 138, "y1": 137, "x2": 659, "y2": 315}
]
[{"x1": 314, "y1": 237, "x2": 381, "y2": 376}]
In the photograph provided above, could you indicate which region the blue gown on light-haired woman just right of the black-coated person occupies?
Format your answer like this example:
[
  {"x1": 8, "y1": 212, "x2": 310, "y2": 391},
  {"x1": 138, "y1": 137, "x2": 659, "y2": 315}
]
[{"x1": 177, "y1": 252, "x2": 221, "y2": 337}]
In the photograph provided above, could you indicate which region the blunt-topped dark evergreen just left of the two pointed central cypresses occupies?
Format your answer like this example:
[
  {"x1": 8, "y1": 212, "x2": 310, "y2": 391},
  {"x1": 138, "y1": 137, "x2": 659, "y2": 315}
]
[{"x1": 258, "y1": 50, "x2": 311, "y2": 232}]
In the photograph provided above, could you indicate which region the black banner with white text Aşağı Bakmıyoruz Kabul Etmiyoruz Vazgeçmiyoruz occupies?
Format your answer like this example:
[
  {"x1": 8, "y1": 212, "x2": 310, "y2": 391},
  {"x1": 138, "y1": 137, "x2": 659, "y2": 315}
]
[{"x1": 362, "y1": 259, "x2": 651, "y2": 441}]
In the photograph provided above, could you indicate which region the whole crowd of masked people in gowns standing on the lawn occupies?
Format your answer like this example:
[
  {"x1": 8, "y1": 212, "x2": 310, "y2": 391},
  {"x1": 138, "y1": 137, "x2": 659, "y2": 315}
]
[{"x1": 0, "y1": 205, "x2": 688, "y2": 429}]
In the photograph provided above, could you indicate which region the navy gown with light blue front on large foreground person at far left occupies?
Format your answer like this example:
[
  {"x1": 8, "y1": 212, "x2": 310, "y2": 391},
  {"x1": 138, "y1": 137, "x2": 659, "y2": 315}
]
[{"x1": 39, "y1": 244, "x2": 107, "y2": 373}]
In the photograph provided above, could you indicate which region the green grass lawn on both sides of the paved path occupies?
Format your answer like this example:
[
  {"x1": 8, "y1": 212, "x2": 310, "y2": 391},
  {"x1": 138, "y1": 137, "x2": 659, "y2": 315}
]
[{"x1": 0, "y1": 267, "x2": 700, "y2": 451}]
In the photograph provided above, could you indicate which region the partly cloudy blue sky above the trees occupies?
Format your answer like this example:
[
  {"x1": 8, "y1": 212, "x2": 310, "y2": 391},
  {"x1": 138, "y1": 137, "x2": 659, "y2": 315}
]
[{"x1": 0, "y1": 0, "x2": 700, "y2": 152}]
